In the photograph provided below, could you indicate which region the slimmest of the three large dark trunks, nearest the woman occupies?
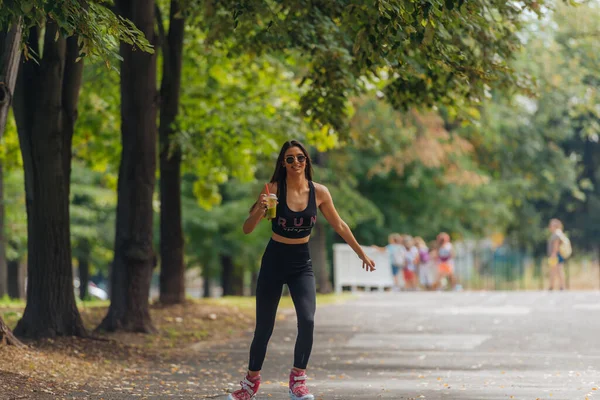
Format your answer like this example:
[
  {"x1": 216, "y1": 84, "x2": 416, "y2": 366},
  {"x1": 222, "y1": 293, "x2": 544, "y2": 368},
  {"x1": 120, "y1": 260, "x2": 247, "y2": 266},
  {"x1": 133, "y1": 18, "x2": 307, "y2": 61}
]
[{"x1": 159, "y1": 0, "x2": 185, "y2": 304}]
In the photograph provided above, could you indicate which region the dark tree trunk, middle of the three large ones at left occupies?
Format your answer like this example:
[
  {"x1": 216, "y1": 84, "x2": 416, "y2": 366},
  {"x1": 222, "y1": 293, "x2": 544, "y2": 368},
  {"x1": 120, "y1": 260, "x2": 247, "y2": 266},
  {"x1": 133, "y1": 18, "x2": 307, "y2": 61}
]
[{"x1": 98, "y1": 0, "x2": 157, "y2": 333}]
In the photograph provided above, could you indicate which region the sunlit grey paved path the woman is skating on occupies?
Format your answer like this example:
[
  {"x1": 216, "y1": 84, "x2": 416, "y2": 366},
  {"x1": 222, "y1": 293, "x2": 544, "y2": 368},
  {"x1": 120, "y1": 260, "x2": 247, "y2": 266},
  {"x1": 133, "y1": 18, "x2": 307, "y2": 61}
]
[{"x1": 196, "y1": 292, "x2": 600, "y2": 400}]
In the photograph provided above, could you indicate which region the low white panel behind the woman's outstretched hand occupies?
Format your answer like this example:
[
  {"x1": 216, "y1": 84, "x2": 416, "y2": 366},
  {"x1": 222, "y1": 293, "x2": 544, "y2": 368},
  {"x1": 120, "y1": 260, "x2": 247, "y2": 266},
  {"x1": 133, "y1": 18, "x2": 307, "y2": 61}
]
[{"x1": 333, "y1": 243, "x2": 402, "y2": 293}]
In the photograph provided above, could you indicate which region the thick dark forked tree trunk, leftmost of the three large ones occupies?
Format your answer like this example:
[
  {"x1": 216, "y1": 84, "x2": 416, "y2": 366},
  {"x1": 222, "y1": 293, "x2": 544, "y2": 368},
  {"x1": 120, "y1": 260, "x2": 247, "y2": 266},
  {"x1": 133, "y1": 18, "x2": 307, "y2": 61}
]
[{"x1": 14, "y1": 22, "x2": 86, "y2": 338}]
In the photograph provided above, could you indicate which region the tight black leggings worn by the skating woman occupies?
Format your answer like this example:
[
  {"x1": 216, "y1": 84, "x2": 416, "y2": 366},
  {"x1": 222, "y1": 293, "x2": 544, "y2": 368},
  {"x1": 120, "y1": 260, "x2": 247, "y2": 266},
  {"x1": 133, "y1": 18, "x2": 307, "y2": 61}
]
[{"x1": 248, "y1": 240, "x2": 316, "y2": 371}]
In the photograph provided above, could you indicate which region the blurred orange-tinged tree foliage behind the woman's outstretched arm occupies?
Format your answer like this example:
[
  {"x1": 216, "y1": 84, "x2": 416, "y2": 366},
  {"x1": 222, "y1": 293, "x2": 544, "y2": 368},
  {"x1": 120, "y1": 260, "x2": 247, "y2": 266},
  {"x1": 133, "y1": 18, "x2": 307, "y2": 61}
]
[{"x1": 322, "y1": 93, "x2": 510, "y2": 244}]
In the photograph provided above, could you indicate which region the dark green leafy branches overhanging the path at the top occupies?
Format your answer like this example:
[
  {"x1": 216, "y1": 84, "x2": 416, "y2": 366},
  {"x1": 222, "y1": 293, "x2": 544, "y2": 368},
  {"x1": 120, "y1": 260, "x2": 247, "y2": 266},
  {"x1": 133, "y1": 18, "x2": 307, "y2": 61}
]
[{"x1": 207, "y1": 0, "x2": 551, "y2": 132}]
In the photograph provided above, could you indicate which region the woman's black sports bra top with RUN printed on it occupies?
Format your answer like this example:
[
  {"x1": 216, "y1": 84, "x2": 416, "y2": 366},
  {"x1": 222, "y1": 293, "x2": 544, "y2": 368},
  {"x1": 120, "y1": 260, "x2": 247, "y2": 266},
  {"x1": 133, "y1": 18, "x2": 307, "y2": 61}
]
[{"x1": 271, "y1": 181, "x2": 317, "y2": 239}]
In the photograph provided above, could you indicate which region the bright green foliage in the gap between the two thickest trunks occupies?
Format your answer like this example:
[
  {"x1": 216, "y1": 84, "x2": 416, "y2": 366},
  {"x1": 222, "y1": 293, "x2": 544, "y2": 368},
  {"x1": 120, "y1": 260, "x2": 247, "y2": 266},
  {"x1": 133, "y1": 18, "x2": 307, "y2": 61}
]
[{"x1": 70, "y1": 61, "x2": 121, "y2": 273}]
